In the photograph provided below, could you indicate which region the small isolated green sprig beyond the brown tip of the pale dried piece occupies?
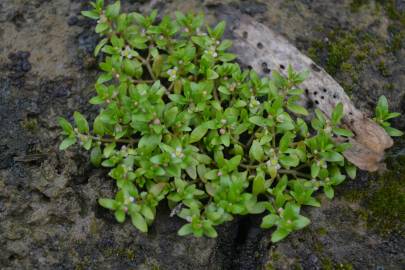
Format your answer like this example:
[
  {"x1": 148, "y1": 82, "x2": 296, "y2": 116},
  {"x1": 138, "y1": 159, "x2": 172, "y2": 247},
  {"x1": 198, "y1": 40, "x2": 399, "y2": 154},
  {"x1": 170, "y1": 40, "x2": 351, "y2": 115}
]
[{"x1": 373, "y1": 96, "x2": 404, "y2": 137}]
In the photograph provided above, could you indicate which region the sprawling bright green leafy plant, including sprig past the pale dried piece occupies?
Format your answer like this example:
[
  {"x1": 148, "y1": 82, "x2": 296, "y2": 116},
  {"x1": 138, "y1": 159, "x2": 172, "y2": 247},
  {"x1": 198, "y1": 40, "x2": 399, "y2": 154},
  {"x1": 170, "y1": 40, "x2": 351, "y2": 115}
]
[{"x1": 59, "y1": 0, "x2": 396, "y2": 241}]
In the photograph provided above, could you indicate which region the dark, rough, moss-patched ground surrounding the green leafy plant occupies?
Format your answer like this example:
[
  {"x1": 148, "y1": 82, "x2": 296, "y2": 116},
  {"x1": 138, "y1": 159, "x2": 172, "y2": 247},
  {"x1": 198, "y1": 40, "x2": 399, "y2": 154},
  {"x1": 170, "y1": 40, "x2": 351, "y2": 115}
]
[{"x1": 0, "y1": 0, "x2": 405, "y2": 270}]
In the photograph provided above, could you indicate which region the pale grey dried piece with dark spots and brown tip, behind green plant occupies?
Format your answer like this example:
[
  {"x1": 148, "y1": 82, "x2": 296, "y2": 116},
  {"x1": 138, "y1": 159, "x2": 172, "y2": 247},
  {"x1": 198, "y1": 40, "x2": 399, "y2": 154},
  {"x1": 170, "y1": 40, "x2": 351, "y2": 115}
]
[{"x1": 218, "y1": 10, "x2": 393, "y2": 171}]
